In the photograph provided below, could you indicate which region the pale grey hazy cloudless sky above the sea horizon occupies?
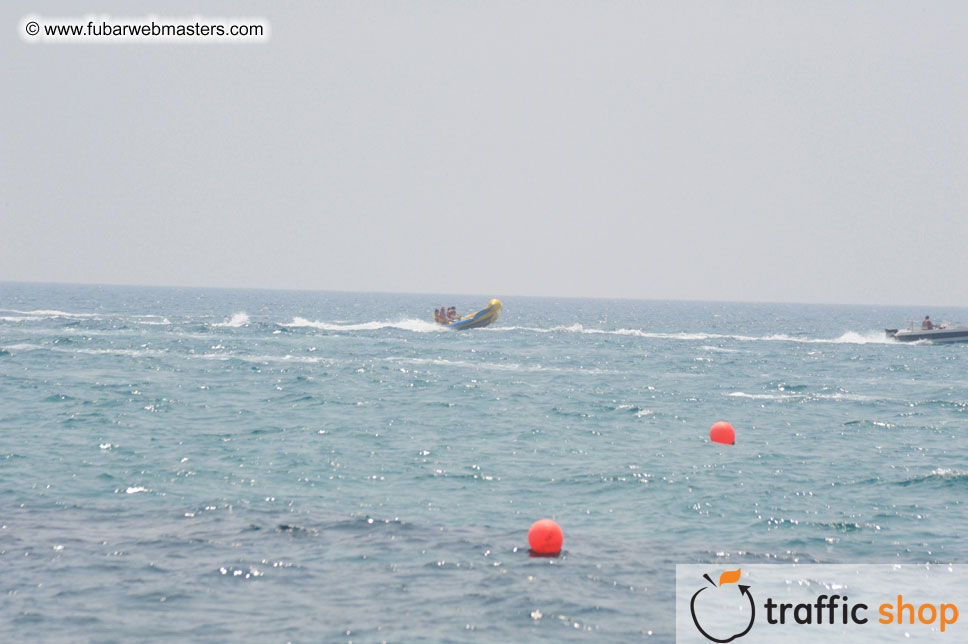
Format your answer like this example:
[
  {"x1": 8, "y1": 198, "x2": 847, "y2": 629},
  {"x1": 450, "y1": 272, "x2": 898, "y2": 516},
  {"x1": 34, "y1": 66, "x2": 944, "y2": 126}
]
[{"x1": 0, "y1": 0, "x2": 968, "y2": 306}]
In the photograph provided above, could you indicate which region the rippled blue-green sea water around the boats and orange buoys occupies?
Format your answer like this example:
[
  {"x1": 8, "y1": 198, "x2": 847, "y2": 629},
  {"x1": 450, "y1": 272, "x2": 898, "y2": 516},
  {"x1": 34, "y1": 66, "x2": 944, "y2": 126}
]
[{"x1": 0, "y1": 284, "x2": 968, "y2": 642}]
